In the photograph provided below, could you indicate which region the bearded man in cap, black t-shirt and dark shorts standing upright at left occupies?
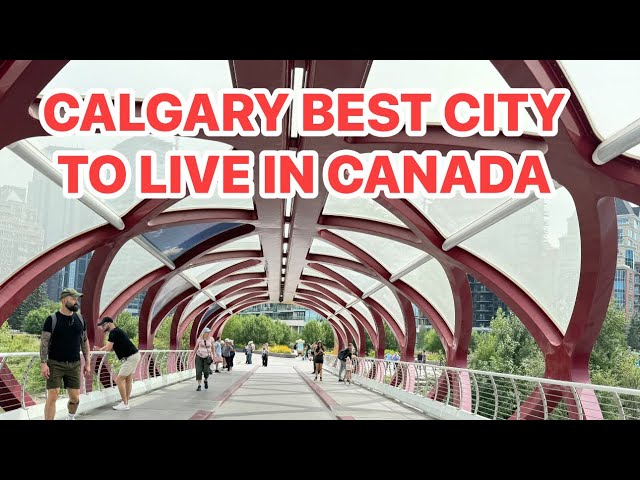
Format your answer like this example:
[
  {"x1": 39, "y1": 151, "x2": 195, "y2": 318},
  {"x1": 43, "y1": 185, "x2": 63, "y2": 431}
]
[{"x1": 40, "y1": 288, "x2": 91, "y2": 420}]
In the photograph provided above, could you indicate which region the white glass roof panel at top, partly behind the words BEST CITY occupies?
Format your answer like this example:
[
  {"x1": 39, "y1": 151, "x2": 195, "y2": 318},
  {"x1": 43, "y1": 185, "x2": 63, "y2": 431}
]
[{"x1": 365, "y1": 60, "x2": 535, "y2": 132}]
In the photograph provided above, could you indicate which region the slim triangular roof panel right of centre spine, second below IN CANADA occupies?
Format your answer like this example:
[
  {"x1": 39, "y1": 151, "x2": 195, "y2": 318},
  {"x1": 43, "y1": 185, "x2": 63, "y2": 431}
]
[{"x1": 329, "y1": 229, "x2": 423, "y2": 274}]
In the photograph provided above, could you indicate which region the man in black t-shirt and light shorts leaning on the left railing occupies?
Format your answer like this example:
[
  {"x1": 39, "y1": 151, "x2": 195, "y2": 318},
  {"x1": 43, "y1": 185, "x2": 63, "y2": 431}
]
[{"x1": 94, "y1": 317, "x2": 140, "y2": 410}]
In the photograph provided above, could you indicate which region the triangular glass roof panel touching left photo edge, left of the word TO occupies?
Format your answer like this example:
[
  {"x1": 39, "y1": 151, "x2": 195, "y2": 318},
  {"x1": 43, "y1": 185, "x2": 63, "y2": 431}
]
[{"x1": 0, "y1": 148, "x2": 107, "y2": 283}]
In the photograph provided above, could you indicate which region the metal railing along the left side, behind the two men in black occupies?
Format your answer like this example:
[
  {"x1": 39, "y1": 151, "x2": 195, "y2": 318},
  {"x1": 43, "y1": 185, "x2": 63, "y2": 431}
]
[{"x1": 0, "y1": 350, "x2": 194, "y2": 413}]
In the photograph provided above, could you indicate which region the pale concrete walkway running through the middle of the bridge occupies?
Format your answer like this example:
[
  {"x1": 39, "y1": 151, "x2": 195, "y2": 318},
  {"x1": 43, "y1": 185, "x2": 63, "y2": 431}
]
[{"x1": 78, "y1": 354, "x2": 428, "y2": 420}]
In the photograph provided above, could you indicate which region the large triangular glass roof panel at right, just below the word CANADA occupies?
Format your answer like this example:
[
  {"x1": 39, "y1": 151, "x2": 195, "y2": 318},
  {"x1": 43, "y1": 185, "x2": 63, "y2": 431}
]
[{"x1": 460, "y1": 188, "x2": 581, "y2": 333}]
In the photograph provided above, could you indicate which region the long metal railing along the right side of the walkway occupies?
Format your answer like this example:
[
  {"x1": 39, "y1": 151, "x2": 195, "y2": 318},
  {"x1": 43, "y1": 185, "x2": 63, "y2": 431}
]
[{"x1": 325, "y1": 355, "x2": 640, "y2": 420}]
